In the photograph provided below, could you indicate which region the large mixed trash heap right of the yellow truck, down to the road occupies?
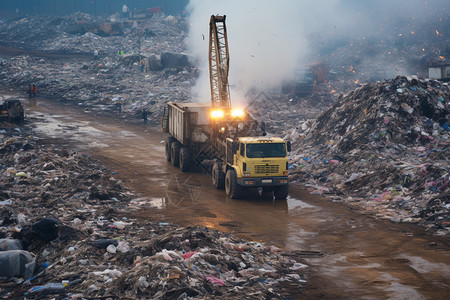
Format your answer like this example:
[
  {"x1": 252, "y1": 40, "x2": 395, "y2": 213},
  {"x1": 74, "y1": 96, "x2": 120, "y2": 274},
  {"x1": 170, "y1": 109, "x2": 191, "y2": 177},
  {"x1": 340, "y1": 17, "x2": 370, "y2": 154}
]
[{"x1": 291, "y1": 76, "x2": 450, "y2": 234}]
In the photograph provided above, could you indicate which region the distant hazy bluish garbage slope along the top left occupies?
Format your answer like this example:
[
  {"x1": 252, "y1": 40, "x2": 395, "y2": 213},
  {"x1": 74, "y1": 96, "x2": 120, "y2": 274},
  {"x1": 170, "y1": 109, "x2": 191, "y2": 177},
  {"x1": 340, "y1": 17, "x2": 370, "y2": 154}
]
[{"x1": 0, "y1": 12, "x2": 186, "y2": 54}]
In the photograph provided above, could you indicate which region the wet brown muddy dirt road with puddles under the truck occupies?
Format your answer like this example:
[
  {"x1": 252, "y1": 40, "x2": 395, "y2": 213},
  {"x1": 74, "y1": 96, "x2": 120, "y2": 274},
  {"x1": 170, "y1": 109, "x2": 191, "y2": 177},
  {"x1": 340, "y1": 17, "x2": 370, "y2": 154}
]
[{"x1": 16, "y1": 99, "x2": 450, "y2": 299}]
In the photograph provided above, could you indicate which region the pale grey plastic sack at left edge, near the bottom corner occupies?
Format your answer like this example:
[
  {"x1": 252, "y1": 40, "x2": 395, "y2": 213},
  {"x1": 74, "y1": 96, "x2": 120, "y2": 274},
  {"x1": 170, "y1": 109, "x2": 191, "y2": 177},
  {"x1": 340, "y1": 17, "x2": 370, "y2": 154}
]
[{"x1": 0, "y1": 250, "x2": 36, "y2": 278}]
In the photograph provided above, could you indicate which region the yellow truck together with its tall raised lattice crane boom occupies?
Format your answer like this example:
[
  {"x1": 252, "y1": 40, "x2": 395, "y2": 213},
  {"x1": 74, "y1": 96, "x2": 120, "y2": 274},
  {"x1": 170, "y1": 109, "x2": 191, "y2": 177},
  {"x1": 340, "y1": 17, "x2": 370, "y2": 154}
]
[{"x1": 161, "y1": 15, "x2": 291, "y2": 199}]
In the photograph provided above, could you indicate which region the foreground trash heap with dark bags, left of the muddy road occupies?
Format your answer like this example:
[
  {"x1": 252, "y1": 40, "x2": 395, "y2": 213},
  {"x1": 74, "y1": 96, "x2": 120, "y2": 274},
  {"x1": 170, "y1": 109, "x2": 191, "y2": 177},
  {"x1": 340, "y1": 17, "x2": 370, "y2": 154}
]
[{"x1": 0, "y1": 126, "x2": 306, "y2": 299}]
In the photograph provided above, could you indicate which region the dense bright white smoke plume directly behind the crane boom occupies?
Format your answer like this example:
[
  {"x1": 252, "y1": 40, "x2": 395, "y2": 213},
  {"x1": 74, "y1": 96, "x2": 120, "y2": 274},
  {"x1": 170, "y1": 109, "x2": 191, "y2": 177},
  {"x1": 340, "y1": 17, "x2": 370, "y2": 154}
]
[{"x1": 186, "y1": 0, "x2": 346, "y2": 103}]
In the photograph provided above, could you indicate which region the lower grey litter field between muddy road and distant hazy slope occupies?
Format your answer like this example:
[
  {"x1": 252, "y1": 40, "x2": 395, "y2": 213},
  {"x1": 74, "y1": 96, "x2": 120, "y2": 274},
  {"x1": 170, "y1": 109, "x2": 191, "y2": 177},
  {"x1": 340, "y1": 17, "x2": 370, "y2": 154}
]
[{"x1": 0, "y1": 55, "x2": 195, "y2": 124}]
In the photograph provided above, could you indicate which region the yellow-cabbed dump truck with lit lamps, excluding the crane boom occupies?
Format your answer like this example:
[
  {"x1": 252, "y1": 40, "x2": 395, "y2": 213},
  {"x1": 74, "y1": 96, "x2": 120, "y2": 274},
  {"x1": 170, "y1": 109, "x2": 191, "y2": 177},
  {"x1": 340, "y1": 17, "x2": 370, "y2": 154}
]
[{"x1": 162, "y1": 102, "x2": 291, "y2": 199}]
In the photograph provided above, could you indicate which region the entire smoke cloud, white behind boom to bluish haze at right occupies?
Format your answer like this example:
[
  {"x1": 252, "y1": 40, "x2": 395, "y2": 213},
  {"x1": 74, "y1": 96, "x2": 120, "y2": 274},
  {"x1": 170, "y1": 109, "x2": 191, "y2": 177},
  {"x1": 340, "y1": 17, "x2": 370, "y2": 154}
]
[{"x1": 186, "y1": 0, "x2": 448, "y2": 104}]
